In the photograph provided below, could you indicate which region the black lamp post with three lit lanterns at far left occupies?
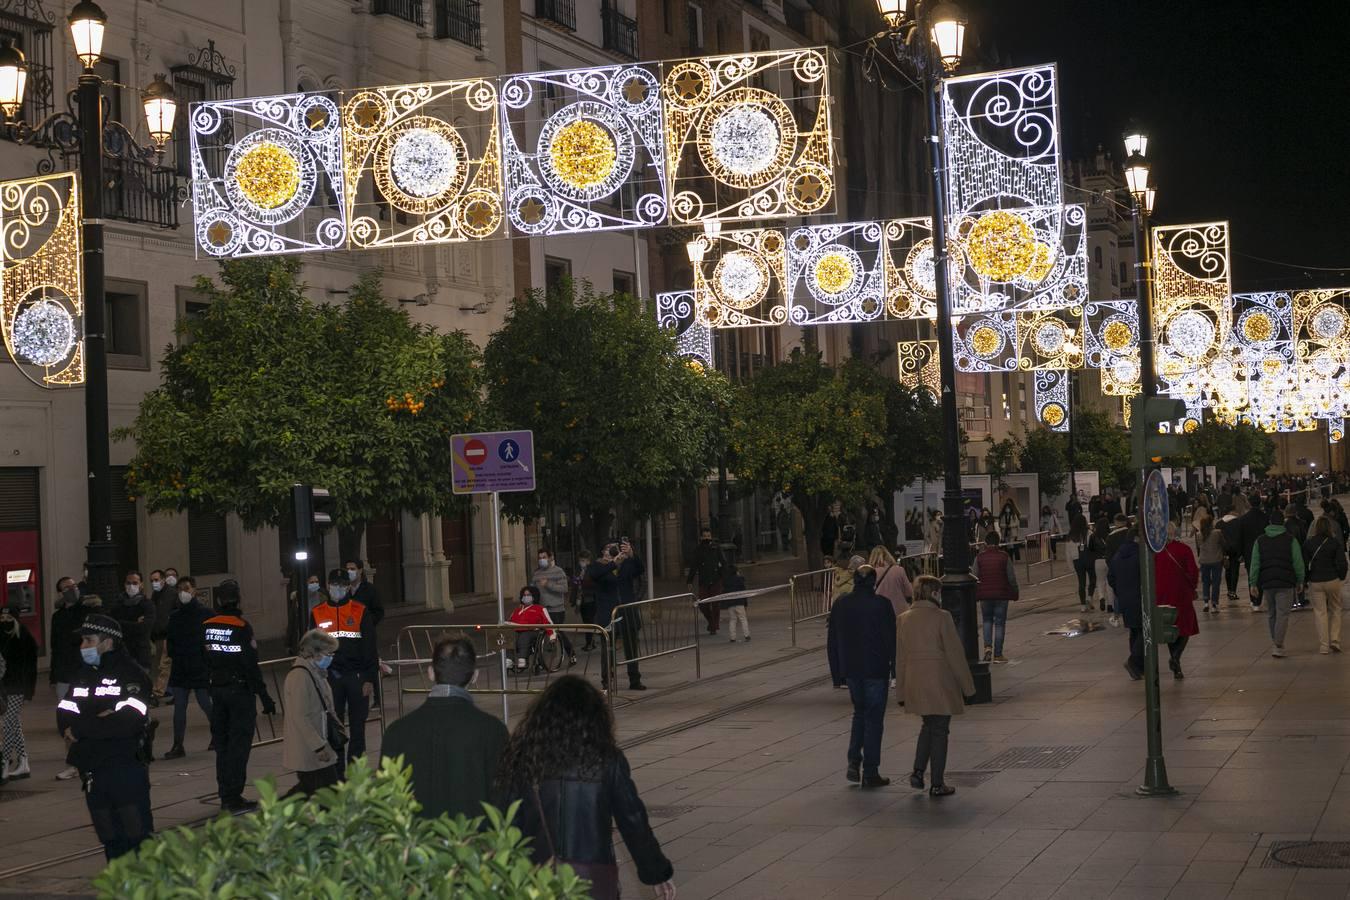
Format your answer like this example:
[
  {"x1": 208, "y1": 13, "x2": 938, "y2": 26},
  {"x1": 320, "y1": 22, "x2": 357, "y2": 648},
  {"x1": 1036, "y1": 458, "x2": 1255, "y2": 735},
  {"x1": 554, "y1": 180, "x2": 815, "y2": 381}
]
[{"x1": 0, "y1": 7, "x2": 177, "y2": 599}]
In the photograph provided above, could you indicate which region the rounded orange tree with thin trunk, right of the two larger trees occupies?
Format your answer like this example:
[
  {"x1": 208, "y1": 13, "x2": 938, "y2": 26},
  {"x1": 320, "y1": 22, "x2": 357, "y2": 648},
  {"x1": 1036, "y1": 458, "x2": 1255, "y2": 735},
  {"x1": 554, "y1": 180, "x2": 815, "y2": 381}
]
[{"x1": 730, "y1": 349, "x2": 941, "y2": 564}]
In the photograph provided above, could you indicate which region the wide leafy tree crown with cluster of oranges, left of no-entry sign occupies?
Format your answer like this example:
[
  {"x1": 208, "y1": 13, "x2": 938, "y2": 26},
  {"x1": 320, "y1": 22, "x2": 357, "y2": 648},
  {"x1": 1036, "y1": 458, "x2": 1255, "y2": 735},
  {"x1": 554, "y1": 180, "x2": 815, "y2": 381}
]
[{"x1": 116, "y1": 259, "x2": 481, "y2": 528}]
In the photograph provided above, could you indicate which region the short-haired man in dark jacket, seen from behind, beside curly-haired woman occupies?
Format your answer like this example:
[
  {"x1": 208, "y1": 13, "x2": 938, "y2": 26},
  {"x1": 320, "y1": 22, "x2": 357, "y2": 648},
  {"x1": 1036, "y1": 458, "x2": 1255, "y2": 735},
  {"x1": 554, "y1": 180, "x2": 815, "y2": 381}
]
[{"x1": 379, "y1": 638, "x2": 509, "y2": 819}]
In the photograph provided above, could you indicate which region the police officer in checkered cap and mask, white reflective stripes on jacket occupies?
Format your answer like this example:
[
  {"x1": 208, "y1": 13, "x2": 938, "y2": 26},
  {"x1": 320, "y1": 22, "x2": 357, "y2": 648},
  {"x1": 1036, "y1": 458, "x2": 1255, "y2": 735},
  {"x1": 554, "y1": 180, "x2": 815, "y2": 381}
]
[{"x1": 57, "y1": 614, "x2": 155, "y2": 860}]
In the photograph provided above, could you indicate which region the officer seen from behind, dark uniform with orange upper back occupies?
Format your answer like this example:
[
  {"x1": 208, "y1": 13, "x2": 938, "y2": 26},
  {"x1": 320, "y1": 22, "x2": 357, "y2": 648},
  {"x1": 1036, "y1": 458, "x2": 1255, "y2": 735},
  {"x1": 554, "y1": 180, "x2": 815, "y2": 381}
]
[{"x1": 203, "y1": 579, "x2": 277, "y2": 812}]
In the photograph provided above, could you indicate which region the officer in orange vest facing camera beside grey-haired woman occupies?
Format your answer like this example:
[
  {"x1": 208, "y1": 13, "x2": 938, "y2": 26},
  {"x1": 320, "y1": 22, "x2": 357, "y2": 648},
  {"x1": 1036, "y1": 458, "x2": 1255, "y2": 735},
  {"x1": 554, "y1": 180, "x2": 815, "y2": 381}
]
[{"x1": 313, "y1": 569, "x2": 379, "y2": 770}]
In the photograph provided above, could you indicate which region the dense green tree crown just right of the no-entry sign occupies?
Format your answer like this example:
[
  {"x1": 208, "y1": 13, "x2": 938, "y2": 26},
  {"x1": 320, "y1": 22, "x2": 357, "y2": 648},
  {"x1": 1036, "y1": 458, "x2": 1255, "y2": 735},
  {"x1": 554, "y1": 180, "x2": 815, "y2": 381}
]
[{"x1": 483, "y1": 283, "x2": 728, "y2": 531}]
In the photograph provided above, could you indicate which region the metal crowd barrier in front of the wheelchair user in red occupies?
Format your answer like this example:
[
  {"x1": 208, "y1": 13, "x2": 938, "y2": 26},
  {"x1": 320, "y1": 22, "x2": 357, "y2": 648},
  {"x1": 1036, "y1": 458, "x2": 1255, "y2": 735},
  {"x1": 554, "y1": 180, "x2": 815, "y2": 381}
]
[{"x1": 385, "y1": 622, "x2": 613, "y2": 715}]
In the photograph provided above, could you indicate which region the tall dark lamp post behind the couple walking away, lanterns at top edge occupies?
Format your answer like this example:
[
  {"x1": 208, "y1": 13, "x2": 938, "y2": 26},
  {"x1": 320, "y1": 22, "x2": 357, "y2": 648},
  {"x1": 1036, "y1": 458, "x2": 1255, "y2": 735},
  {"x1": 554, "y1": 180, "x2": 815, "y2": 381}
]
[{"x1": 876, "y1": 0, "x2": 992, "y2": 703}]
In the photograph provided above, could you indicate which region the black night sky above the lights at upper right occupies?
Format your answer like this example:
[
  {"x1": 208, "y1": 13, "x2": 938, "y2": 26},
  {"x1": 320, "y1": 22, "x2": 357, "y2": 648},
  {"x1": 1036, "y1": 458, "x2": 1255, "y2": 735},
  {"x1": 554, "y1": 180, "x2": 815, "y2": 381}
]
[{"x1": 961, "y1": 0, "x2": 1350, "y2": 291}]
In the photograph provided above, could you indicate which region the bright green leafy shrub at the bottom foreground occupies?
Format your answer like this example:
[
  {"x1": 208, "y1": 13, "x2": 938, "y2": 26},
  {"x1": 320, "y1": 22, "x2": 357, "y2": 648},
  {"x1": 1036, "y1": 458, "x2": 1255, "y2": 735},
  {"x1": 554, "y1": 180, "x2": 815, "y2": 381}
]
[{"x1": 95, "y1": 760, "x2": 589, "y2": 900}]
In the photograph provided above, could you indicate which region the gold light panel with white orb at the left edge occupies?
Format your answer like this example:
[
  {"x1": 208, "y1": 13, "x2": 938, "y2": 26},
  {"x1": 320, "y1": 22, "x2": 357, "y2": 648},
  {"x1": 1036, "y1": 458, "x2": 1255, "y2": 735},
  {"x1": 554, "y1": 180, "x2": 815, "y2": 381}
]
[{"x1": 0, "y1": 173, "x2": 85, "y2": 387}]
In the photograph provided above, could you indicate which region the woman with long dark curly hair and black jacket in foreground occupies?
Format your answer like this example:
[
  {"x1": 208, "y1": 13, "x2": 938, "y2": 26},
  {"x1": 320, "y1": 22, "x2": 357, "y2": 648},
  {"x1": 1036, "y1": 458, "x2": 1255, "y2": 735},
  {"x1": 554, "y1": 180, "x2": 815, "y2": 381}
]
[{"x1": 497, "y1": 675, "x2": 675, "y2": 900}]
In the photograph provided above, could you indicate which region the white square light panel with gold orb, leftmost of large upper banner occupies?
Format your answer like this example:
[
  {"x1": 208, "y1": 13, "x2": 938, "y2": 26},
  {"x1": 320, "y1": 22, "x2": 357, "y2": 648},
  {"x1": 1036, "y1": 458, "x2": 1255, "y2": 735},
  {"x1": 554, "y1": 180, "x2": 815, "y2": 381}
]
[{"x1": 188, "y1": 93, "x2": 347, "y2": 256}]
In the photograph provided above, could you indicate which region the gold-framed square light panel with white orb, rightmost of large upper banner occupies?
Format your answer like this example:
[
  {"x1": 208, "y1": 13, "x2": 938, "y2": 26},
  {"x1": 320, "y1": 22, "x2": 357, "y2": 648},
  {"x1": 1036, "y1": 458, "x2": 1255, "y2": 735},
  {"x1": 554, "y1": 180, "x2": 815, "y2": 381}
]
[{"x1": 662, "y1": 49, "x2": 834, "y2": 223}]
